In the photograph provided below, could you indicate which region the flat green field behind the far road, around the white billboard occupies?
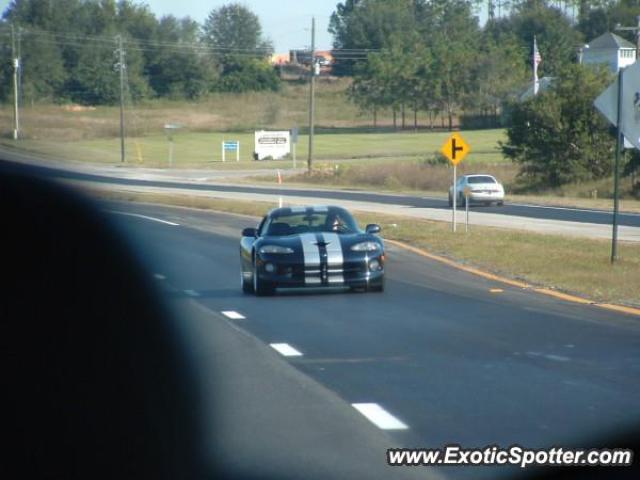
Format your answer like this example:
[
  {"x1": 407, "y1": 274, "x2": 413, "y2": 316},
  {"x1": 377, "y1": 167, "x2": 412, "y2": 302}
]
[{"x1": 5, "y1": 130, "x2": 505, "y2": 168}]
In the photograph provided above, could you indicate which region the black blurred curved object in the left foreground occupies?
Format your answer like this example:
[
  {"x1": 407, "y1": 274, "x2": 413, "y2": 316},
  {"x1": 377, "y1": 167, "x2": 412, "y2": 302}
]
[{"x1": 0, "y1": 162, "x2": 203, "y2": 480}]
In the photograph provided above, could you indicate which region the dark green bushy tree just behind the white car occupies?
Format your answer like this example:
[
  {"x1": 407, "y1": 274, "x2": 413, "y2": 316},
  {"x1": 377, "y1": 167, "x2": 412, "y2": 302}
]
[{"x1": 501, "y1": 65, "x2": 615, "y2": 189}]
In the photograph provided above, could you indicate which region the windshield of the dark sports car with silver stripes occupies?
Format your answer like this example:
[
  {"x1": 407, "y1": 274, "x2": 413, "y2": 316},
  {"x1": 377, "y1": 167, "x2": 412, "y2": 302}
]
[{"x1": 264, "y1": 209, "x2": 360, "y2": 236}]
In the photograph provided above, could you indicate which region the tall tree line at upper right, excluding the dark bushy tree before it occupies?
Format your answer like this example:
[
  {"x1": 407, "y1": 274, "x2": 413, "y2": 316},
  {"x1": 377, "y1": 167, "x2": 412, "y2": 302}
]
[{"x1": 330, "y1": 0, "x2": 640, "y2": 127}]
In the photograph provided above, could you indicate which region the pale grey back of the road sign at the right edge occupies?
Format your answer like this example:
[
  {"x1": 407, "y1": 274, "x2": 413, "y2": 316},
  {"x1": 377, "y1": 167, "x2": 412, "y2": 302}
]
[{"x1": 594, "y1": 62, "x2": 640, "y2": 149}]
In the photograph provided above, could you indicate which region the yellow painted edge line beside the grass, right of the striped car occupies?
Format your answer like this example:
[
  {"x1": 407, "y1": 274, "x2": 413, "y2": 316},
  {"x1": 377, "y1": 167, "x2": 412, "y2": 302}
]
[{"x1": 385, "y1": 239, "x2": 640, "y2": 317}]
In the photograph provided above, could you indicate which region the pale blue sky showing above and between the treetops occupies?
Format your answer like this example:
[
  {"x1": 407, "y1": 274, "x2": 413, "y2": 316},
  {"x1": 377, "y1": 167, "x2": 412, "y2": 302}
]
[{"x1": 0, "y1": 0, "x2": 486, "y2": 53}]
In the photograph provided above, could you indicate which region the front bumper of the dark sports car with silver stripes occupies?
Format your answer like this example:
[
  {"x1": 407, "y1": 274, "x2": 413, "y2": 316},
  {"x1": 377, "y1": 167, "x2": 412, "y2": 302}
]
[{"x1": 256, "y1": 254, "x2": 385, "y2": 288}]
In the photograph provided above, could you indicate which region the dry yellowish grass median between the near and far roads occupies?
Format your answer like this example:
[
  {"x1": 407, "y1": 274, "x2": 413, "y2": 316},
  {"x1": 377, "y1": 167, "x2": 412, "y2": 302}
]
[{"x1": 89, "y1": 189, "x2": 640, "y2": 307}]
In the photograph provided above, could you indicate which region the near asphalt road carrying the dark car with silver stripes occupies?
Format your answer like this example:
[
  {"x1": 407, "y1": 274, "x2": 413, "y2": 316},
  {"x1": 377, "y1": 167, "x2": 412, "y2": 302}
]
[{"x1": 103, "y1": 203, "x2": 640, "y2": 478}]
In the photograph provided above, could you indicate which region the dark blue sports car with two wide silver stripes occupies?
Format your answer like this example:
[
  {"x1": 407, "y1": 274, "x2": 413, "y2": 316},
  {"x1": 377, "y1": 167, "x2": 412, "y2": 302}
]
[{"x1": 240, "y1": 206, "x2": 385, "y2": 295}]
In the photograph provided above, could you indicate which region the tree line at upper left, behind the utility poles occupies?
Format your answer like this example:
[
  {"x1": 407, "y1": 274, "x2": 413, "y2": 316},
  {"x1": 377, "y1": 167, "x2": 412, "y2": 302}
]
[{"x1": 0, "y1": 0, "x2": 279, "y2": 105}]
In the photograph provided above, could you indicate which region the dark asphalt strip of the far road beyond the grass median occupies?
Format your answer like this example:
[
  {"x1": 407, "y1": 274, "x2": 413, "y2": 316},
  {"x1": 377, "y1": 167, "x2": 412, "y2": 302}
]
[{"x1": 2, "y1": 151, "x2": 640, "y2": 227}]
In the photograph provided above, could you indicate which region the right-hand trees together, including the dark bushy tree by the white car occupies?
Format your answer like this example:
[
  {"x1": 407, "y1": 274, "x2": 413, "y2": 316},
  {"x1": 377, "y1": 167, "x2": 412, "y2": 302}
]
[{"x1": 330, "y1": 0, "x2": 640, "y2": 191}]
